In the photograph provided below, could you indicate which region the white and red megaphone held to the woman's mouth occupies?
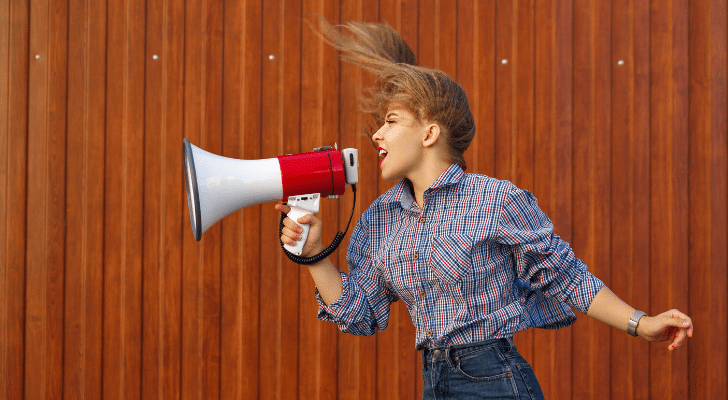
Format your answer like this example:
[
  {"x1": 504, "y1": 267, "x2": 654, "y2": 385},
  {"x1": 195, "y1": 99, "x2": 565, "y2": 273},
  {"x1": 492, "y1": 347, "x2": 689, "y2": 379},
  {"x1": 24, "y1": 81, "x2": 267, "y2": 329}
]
[{"x1": 183, "y1": 138, "x2": 359, "y2": 256}]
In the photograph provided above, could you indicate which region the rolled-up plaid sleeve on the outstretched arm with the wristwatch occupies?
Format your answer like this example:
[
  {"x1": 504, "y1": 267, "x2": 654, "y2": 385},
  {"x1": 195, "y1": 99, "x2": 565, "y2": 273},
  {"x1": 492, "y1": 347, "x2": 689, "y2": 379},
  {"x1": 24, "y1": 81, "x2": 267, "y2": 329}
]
[{"x1": 497, "y1": 186, "x2": 604, "y2": 313}]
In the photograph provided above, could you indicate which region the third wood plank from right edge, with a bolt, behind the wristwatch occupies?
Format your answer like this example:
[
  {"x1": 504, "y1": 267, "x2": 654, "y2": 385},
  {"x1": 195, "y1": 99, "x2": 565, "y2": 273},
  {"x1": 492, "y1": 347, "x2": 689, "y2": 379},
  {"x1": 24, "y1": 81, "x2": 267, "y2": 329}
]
[{"x1": 611, "y1": 1, "x2": 649, "y2": 399}]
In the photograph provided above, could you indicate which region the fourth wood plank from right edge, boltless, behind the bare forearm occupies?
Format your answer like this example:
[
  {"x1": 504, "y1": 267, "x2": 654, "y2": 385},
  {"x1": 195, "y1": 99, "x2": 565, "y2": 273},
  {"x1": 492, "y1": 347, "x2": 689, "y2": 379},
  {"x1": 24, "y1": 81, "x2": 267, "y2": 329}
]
[{"x1": 573, "y1": 2, "x2": 612, "y2": 398}]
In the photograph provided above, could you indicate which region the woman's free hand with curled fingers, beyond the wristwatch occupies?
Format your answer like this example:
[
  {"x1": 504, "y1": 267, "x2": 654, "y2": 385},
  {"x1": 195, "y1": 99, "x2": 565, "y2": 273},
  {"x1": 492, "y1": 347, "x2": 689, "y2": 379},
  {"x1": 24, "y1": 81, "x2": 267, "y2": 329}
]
[{"x1": 637, "y1": 310, "x2": 693, "y2": 350}]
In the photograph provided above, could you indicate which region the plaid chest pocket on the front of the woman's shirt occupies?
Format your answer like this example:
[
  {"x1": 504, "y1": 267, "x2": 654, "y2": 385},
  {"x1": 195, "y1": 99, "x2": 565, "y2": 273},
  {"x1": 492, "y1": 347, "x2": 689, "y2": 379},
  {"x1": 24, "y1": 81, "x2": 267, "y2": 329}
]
[{"x1": 430, "y1": 235, "x2": 473, "y2": 285}]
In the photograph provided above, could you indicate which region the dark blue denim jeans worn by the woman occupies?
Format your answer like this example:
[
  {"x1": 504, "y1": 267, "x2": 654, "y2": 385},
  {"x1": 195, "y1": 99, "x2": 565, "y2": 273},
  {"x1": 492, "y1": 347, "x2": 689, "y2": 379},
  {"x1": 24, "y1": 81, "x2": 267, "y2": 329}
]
[{"x1": 422, "y1": 338, "x2": 544, "y2": 400}]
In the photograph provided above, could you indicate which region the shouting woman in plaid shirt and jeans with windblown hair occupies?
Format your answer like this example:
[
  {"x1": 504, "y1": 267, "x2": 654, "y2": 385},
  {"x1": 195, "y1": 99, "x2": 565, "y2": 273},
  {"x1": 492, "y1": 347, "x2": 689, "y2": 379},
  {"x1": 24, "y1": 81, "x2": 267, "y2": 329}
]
[{"x1": 276, "y1": 21, "x2": 693, "y2": 399}]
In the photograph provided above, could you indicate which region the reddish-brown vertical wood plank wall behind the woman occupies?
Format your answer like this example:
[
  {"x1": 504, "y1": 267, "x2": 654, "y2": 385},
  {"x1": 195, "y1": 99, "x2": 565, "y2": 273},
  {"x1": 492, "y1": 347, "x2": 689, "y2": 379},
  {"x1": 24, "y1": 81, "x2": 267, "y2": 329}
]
[{"x1": 0, "y1": 0, "x2": 728, "y2": 399}]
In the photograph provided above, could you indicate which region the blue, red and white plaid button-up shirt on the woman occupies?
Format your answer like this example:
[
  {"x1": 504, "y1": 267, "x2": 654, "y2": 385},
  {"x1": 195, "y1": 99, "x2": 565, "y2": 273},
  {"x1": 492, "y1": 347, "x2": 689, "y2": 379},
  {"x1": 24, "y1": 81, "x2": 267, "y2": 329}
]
[{"x1": 316, "y1": 165, "x2": 604, "y2": 349}]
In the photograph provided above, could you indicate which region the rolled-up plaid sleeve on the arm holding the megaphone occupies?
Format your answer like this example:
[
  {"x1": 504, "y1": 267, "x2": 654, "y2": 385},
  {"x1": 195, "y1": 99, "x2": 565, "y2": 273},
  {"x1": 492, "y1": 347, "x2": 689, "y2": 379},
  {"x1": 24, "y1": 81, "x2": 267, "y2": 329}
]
[{"x1": 316, "y1": 213, "x2": 398, "y2": 336}]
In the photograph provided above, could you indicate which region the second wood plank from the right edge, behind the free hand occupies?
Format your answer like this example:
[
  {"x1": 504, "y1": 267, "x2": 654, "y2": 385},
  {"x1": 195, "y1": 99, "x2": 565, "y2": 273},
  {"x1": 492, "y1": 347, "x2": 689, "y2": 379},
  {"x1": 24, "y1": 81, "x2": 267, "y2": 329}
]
[{"x1": 650, "y1": 1, "x2": 687, "y2": 399}]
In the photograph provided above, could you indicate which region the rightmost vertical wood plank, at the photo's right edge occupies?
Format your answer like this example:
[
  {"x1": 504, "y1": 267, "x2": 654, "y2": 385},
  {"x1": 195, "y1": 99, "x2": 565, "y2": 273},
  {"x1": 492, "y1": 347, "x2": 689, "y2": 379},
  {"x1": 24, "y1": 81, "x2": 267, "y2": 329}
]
[{"x1": 688, "y1": 1, "x2": 728, "y2": 399}]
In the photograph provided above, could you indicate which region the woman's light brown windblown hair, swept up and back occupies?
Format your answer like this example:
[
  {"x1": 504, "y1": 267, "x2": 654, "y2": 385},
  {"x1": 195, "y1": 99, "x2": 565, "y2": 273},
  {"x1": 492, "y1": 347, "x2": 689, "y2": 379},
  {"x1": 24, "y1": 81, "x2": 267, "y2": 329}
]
[{"x1": 319, "y1": 17, "x2": 475, "y2": 169}]
